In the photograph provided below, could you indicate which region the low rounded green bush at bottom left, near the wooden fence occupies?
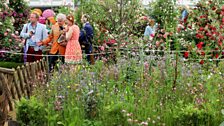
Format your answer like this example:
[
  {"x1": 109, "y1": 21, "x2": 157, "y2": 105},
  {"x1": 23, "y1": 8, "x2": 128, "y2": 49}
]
[{"x1": 16, "y1": 97, "x2": 47, "y2": 126}]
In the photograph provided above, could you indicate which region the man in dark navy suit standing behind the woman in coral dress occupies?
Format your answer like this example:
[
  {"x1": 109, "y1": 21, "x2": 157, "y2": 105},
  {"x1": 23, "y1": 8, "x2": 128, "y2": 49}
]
[{"x1": 79, "y1": 14, "x2": 94, "y2": 64}]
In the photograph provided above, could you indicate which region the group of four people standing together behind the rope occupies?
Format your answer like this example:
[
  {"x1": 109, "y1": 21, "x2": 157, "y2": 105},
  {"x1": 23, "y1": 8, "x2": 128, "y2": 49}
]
[{"x1": 20, "y1": 12, "x2": 94, "y2": 71}]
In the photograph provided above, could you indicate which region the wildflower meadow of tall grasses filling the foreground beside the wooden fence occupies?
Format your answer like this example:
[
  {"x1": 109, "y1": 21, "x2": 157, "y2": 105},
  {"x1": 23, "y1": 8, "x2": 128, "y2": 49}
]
[{"x1": 17, "y1": 58, "x2": 224, "y2": 126}]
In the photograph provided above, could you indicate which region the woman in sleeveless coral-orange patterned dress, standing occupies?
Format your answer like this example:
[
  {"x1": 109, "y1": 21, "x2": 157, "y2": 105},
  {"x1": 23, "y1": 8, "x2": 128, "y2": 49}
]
[{"x1": 65, "y1": 15, "x2": 82, "y2": 64}]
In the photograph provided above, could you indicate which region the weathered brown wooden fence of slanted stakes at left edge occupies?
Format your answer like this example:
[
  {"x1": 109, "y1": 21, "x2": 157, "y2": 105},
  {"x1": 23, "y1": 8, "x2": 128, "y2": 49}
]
[{"x1": 0, "y1": 59, "x2": 48, "y2": 126}]
